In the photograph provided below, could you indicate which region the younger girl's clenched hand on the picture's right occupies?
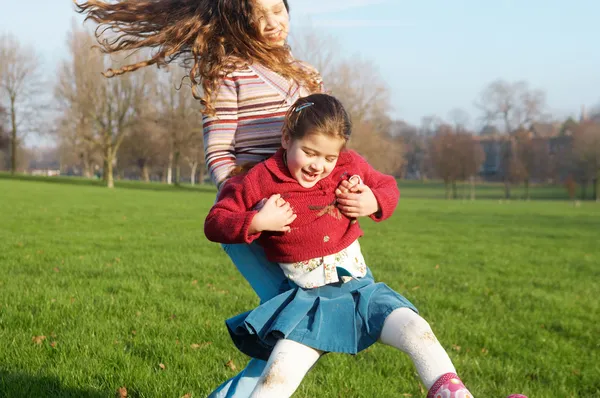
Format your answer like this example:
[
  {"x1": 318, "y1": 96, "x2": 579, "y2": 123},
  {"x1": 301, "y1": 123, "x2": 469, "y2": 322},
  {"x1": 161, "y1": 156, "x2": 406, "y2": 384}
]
[{"x1": 335, "y1": 181, "x2": 379, "y2": 218}]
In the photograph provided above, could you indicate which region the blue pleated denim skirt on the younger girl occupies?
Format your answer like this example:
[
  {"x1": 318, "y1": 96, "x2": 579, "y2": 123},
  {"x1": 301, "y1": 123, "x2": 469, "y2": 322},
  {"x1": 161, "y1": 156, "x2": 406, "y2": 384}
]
[{"x1": 225, "y1": 274, "x2": 418, "y2": 360}]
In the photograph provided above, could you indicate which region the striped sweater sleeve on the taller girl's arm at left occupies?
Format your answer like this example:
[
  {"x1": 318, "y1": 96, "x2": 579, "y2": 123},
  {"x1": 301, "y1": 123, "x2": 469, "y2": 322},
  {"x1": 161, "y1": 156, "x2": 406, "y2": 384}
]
[{"x1": 202, "y1": 74, "x2": 238, "y2": 188}]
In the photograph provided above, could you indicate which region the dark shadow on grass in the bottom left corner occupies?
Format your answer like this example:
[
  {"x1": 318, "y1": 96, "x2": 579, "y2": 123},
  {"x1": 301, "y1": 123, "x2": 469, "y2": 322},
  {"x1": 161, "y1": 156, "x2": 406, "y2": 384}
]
[{"x1": 0, "y1": 370, "x2": 109, "y2": 398}]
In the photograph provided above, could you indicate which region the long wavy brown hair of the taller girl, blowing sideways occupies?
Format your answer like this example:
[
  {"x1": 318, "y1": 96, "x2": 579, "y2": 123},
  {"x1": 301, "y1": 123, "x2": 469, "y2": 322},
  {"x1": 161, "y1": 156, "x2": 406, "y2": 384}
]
[{"x1": 73, "y1": 0, "x2": 319, "y2": 114}]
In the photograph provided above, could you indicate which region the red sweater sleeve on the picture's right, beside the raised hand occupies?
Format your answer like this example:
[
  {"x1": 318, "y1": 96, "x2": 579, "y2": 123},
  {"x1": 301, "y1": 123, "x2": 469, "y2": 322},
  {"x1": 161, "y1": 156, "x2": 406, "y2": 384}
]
[{"x1": 353, "y1": 153, "x2": 400, "y2": 222}]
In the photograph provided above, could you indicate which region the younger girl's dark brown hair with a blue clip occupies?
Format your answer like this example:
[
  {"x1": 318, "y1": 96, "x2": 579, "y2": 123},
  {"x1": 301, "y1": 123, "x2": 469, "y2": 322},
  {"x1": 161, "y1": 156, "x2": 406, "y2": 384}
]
[{"x1": 282, "y1": 94, "x2": 352, "y2": 141}]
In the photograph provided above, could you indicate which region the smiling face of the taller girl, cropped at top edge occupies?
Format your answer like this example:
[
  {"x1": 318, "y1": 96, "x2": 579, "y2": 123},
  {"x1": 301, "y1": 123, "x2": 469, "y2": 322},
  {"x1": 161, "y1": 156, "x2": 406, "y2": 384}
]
[{"x1": 253, "y1": 0, "x2": 290, "y2": 46}]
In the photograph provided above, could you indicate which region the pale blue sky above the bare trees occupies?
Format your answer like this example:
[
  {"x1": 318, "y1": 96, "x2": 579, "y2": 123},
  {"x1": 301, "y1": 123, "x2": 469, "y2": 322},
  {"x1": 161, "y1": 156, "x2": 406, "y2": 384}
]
[{"x1": 0, "y1": 0, "x2": 600, "y2": 127}]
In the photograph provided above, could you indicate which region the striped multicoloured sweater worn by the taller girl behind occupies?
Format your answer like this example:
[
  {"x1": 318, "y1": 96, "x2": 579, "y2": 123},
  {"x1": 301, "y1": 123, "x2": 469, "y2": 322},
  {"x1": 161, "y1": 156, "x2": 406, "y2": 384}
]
[{"x1": 203, "y1": 63, "x2": 324, "y2": 188}]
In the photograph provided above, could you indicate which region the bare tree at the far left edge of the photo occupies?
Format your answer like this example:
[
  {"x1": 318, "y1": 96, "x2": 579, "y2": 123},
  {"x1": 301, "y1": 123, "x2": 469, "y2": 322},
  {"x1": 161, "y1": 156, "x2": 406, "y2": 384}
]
[{"x1": 0, "y1": 35, "x2": 40, "y2": 174}]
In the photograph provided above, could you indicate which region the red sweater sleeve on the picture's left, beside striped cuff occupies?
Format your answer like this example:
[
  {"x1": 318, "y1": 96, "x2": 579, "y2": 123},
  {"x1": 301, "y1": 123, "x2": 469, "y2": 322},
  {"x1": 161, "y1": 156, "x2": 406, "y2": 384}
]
[{"x1": 204, "y1": 176, "x2": 260, "y2": 244}]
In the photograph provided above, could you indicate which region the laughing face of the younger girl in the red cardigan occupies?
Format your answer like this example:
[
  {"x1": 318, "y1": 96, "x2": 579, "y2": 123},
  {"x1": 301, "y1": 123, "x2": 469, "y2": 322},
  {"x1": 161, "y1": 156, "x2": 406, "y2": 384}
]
[{"x1": 281, "y1": 133, "x2": 346, "y2": 188}]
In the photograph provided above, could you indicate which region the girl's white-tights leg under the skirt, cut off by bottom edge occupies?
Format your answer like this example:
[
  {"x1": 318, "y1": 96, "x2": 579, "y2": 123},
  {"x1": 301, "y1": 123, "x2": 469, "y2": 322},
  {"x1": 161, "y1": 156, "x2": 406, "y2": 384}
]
[{"x1": 250, "y1": 340, "x2": 322, "y2": 398}]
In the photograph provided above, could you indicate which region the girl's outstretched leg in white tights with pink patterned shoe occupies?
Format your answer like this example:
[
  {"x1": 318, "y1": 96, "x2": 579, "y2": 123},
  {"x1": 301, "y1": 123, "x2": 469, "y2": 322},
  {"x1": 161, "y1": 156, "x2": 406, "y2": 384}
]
[{"x1": 381, "y1": 308, "x2": 473, "y2": 398}]
